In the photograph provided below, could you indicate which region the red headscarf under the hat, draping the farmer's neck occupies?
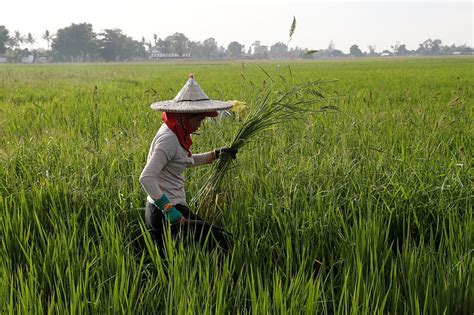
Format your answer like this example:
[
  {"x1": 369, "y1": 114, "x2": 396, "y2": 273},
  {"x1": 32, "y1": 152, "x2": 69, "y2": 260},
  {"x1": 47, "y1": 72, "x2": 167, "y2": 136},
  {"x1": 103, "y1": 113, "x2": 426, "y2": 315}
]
[{"x1": 161, "y1": 112, "x2": 217, "y2": 156}]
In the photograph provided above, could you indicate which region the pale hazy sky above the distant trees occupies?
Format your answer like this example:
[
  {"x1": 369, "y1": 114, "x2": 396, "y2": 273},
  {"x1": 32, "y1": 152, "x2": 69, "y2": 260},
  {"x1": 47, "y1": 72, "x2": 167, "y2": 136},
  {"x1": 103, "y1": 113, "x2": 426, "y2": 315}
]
[{"x1": 0, "y1": 0, "x2": 474, "y2": 52}]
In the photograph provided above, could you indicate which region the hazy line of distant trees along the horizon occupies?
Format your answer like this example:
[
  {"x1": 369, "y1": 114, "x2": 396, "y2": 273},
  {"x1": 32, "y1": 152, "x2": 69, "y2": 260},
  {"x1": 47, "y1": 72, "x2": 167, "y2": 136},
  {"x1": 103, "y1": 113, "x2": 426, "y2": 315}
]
[{"x1": 0, "y1": 23, "x2": 474, "y2": 62}]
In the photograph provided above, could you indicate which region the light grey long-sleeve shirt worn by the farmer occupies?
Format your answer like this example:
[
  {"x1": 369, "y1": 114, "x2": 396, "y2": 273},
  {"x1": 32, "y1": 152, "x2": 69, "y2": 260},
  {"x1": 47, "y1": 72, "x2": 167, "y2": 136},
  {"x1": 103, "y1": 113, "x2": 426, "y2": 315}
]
[{"x1": 140, "y1": 124, "x2": 214, "y2": 205}]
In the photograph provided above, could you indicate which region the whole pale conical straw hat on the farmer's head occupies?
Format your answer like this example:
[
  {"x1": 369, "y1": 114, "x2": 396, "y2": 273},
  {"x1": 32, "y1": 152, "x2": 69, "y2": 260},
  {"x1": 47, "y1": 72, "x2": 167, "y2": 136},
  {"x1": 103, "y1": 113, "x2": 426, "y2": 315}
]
[{"x1": 150, "y1": 74, "x2": 233, "y2": 113}]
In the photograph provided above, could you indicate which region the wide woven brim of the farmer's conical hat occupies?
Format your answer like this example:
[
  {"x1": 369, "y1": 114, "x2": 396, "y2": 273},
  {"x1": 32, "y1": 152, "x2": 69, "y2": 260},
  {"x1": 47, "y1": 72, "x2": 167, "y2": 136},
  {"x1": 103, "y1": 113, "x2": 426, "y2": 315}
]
[{"x1": 150, "y1": 100, "x2": 233, "y2": 113}]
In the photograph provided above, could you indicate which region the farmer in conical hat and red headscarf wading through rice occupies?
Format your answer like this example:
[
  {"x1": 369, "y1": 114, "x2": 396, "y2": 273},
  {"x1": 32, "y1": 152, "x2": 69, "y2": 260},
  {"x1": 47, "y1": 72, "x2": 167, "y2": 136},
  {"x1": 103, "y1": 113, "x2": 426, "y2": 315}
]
[{"x1": 140, "y1": 74, "x2": 237, "y2": 252}]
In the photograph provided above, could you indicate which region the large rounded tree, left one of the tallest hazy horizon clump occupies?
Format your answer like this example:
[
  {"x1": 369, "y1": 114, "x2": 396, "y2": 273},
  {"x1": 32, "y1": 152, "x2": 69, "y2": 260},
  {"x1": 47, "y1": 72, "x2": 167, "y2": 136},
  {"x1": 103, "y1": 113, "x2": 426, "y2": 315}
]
[{"x1": 52, "y1": 23, "x2": 98, "y2": 61}]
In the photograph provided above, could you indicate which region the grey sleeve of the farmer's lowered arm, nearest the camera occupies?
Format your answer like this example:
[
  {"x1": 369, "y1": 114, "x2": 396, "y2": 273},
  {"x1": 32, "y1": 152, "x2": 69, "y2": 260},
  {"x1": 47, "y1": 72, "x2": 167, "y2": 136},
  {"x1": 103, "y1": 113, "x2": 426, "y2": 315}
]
[{"x1": 140, "y1": 140, "x2": 176, "y2": 200}]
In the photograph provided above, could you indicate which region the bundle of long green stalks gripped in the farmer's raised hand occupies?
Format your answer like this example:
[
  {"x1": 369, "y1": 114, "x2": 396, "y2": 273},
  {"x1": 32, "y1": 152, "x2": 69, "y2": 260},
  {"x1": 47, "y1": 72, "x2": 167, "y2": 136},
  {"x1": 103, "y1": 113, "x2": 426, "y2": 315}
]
[{"x1": 191, "y1": 80, "x2": 337, "y2": 217}]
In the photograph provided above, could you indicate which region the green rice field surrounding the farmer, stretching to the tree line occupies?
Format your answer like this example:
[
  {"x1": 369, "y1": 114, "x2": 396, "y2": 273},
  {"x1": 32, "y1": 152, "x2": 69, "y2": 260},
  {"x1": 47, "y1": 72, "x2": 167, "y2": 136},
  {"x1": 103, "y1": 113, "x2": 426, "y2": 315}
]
[{"x1": 0, "y1": 57, "x2": 474, "y2": 314}]
